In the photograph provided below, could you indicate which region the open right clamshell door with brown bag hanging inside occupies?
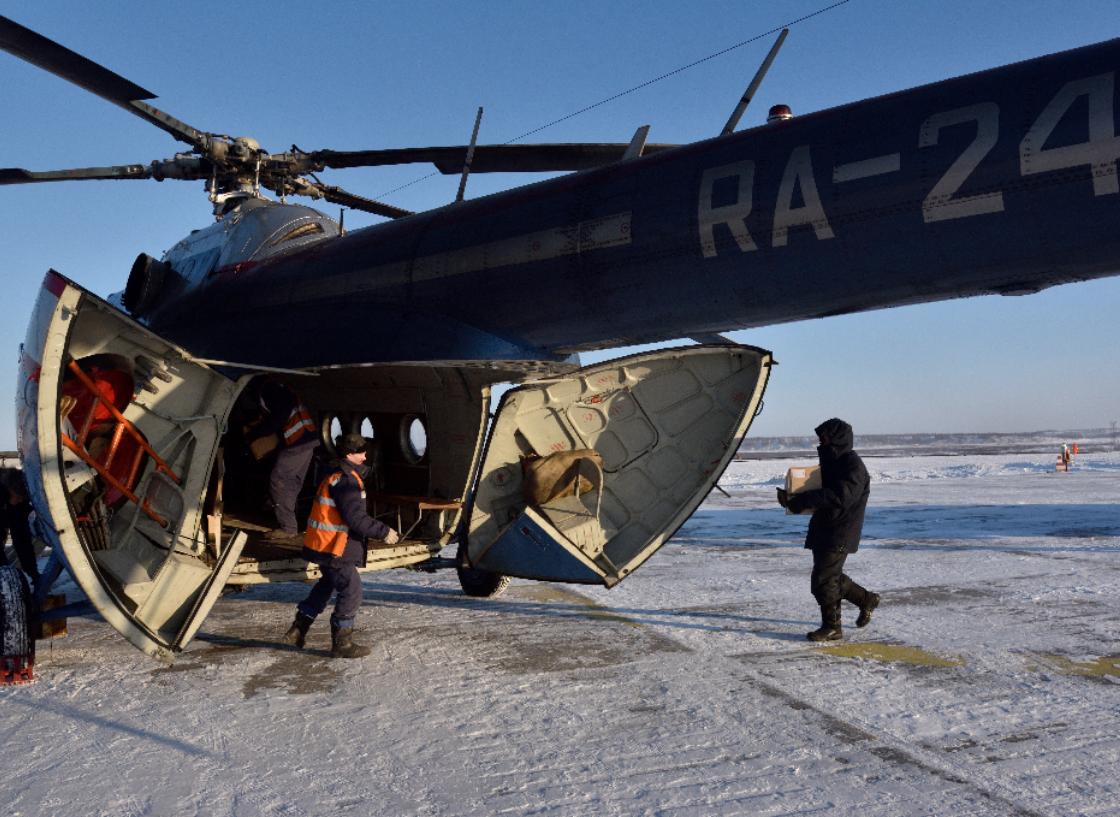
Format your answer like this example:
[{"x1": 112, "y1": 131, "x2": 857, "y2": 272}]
[{"x1": 467, "y1": 344, "x2": 772, "y2": 587}]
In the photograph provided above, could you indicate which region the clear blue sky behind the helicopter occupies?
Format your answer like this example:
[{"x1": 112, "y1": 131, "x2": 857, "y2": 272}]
[{"x1": 0, "y1": 0, "x2": 1120, "y2": 448}]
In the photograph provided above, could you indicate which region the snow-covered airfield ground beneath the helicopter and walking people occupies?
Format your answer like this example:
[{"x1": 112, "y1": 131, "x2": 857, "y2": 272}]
[{"x1": 0, "y1": 440, "x2": 1120, "y2": 817}]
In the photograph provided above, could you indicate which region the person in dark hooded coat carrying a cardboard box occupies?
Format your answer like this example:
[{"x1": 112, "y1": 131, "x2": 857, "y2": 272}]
[{"x1": 777, "y1": 418, "x2": 879, "y2": 641}]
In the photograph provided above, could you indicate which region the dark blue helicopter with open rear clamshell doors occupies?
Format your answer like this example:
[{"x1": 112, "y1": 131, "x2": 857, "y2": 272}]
[{"x1": 0, "y1": 18, "x2": 1120, "y2": 661}]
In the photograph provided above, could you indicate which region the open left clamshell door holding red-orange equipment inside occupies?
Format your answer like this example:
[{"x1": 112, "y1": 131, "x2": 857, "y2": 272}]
[{"x1": 17, "y1": 272, "x2": 245, "y2": 661}]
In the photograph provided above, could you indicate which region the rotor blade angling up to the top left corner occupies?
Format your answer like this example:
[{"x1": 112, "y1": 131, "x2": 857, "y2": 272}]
[{"x1": 0, "y1": 16, "x2": 208, "y2": 148}]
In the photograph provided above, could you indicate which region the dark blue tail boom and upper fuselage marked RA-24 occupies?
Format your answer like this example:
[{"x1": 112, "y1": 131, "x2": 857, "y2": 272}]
[{"x1": 133, "y1": 35, "x2": 1120, "y2": 368}]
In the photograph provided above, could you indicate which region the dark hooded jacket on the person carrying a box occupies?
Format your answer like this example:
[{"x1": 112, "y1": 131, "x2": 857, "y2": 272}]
[{"x1": 788, "y1": 419, "x2": 871, "y2": 554}]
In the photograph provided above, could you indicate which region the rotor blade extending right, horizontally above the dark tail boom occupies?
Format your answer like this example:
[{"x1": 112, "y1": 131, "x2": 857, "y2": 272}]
[{"x1": 296, "y1": 142, "x2": 678, "y2": 174}]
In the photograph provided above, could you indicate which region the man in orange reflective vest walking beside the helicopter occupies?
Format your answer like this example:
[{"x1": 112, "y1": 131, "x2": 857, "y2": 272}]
[{"x1": 283, "y1": 434, "x2": 400, "y2": 658}]
